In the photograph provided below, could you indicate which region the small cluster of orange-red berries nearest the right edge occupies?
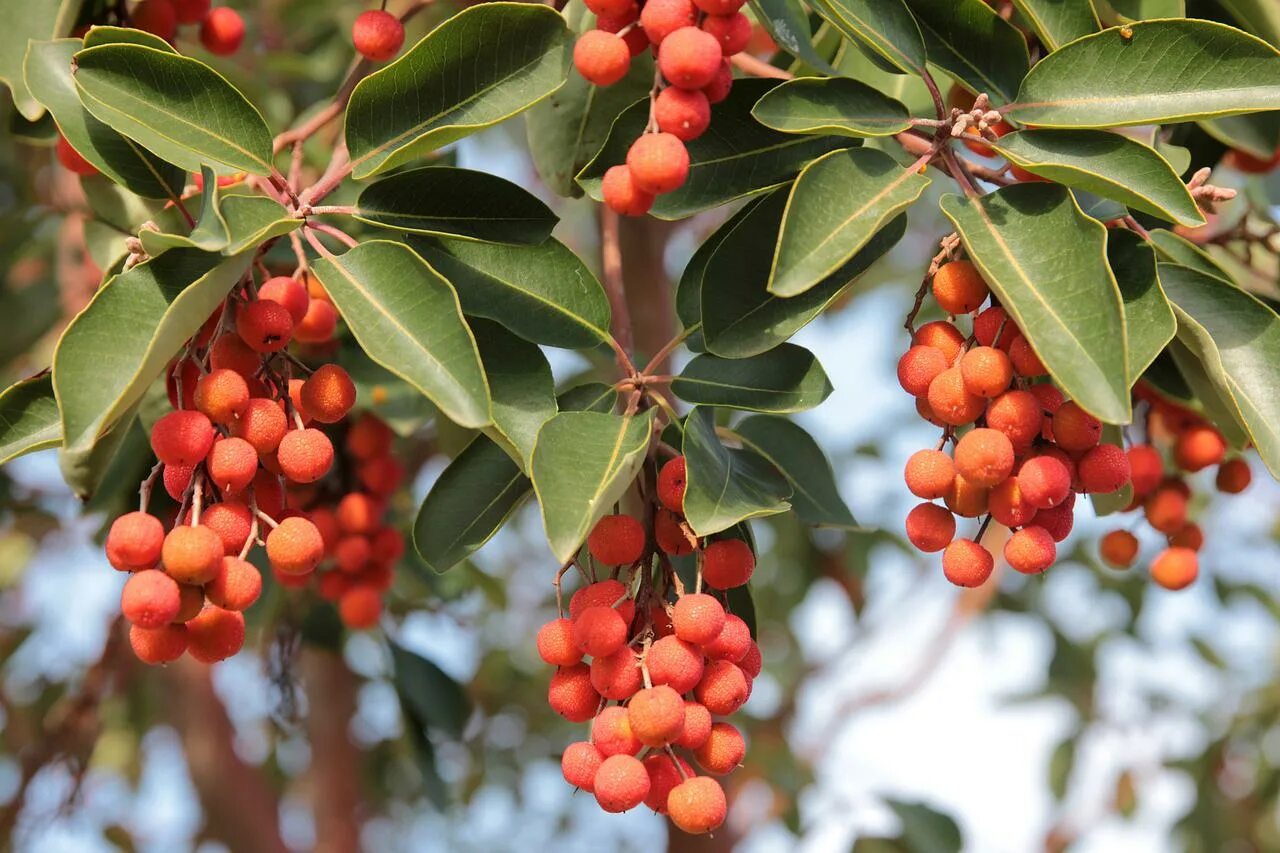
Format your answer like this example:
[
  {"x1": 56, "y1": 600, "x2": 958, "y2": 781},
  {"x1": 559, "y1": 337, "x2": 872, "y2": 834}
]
[{"x1": 1098, "y1": 386, "x2": 1253, "y2": 589}]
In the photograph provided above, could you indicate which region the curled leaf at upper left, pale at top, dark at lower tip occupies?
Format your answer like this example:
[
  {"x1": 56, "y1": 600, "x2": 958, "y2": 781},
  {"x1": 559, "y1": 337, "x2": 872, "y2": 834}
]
[{"x1": 23, "y1": 38, "x2": 187, "y2": 199}]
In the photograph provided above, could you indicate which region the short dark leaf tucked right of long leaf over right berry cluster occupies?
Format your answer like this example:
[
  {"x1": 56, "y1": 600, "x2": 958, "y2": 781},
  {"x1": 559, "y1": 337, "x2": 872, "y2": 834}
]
[{"x1": 1107, "y1": 228, "x2": 1178, "y2": 386}]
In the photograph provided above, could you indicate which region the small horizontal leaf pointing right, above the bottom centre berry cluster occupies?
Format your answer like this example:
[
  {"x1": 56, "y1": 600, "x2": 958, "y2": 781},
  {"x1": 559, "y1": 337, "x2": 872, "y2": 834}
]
[{"x1": 671, "y1": 343, "x2": 831, "y2": 414}]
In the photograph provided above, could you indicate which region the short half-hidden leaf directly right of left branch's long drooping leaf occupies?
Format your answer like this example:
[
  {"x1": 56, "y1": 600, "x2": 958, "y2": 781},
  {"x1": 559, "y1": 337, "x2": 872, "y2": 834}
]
[{"x1": 471, "y1": 319, "x2": 556, "y2": 470}]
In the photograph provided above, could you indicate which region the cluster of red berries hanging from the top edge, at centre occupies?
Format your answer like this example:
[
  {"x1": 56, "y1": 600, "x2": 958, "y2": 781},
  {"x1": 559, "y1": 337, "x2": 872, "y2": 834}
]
[{"x1": 573, "y1": 0, "x2": 751, "y2": 216}]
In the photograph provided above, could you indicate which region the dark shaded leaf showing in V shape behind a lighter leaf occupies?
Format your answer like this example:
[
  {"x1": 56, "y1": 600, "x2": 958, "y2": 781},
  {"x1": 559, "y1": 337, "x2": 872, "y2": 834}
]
[{"x1": 701, "y1": 192, "x2": 906, "y2": 359}]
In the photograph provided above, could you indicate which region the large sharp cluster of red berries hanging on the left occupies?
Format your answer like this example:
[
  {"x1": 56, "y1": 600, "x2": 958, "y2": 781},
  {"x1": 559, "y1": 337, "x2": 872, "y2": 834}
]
[{"x1": 106, "y1": 268, "x2": 368, "y2": 663}]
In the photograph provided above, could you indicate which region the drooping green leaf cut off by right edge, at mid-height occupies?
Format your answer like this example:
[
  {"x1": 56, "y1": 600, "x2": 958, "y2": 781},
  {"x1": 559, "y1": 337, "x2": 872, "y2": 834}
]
[{"x1": 1160, "y1": 264, "x2": 1280, "y2": 479}]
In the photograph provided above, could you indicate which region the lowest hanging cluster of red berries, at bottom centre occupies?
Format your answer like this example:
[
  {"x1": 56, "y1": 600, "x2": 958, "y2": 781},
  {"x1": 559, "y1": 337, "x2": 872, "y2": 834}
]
[{"x1": 538, "y1": 457, "x2": 762, "y2": 833}]
